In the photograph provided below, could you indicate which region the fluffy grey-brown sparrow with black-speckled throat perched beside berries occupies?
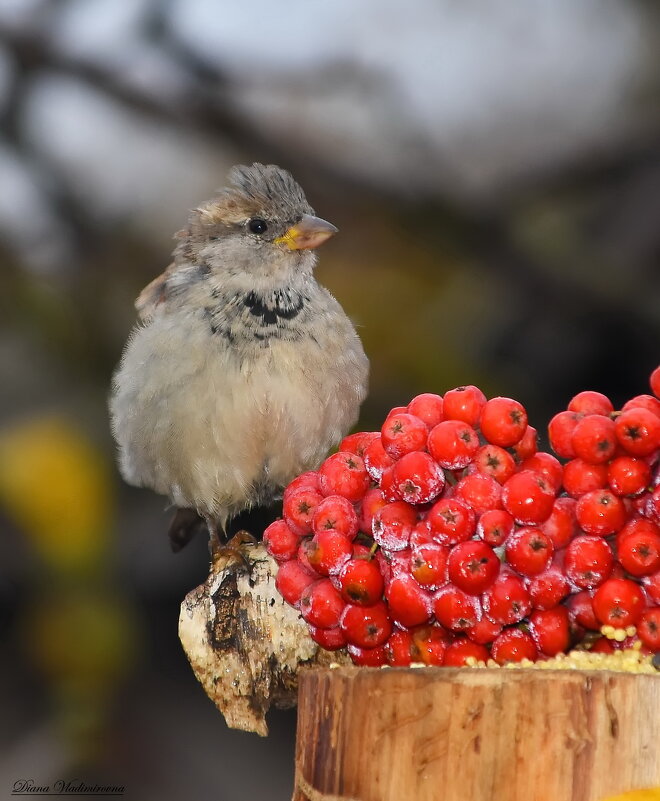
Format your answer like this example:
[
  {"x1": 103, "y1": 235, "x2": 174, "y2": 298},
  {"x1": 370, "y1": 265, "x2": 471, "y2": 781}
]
[{"x1": 109, "y1": 163, "x2": 369, "y2": 553}]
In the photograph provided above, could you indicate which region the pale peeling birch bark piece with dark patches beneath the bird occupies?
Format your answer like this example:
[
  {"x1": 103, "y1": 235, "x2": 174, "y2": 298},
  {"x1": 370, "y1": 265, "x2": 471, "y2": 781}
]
[{"x1": 179, "y1": 535, "x2": 346, "y2": 736}]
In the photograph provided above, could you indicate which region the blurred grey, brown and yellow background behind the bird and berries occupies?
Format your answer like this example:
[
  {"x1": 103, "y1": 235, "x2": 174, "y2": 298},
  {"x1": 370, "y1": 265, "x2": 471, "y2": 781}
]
[{"x1": 0, "y1": 0, "x2": 660, "y2": 801}]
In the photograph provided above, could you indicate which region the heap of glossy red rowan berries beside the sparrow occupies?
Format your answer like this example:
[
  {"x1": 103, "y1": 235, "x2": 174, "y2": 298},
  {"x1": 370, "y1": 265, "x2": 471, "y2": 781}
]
[{"x1": 264, "y1": 367, "x2": 660, "y2": 666}]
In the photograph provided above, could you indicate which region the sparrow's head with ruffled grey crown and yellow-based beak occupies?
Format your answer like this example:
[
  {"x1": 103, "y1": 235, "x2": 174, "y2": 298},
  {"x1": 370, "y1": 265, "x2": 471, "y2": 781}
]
[{"x1": 176, "y1": 164, "x2": 337, "y2": 288}]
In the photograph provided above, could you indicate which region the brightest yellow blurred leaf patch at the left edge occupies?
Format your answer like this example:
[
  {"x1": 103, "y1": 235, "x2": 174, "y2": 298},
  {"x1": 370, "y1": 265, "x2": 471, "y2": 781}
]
[{"x1": 0, "y1": 416, "x2": 113, "y2": 571}]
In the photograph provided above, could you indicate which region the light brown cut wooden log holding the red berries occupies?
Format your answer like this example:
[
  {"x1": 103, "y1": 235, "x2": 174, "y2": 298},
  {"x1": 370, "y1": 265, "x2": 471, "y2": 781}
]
[{"x1": 293, "y1": 668, "x2": 660, "y2": 801}]
